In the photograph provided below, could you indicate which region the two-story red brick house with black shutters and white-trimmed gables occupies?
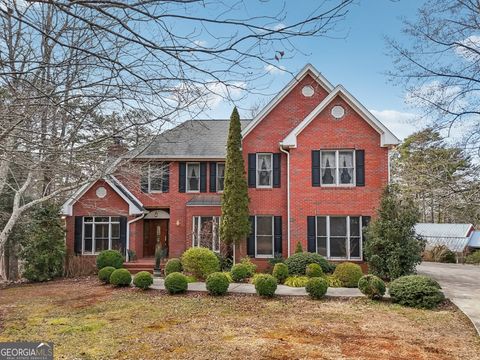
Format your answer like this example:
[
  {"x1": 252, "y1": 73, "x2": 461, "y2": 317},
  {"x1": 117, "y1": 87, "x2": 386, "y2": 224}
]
[{"x1": 63, "y1": 65, "x2": 399, "y2": 272}]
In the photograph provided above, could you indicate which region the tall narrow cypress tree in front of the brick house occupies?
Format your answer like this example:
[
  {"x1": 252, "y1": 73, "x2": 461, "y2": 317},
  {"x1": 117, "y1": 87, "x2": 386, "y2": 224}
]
[{"x1": 220, "y1": 107, "x2": 250, "y2": 244}]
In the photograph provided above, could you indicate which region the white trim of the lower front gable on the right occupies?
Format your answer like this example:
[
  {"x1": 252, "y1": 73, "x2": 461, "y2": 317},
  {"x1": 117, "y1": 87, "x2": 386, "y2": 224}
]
[{"x1": 281, "y1": 85, "x2": 400, "y2": 148}]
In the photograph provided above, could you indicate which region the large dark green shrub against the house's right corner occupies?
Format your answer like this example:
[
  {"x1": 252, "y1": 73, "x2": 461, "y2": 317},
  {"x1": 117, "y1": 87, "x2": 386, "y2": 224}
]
[{"x1": 364, "y1": 186, "x2": 425, "y2": 279}]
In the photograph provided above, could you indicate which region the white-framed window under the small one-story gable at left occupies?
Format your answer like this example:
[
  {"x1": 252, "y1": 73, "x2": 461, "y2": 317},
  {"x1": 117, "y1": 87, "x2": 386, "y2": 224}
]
[{"x1": 82, "y1": 216, "x2": 122, "y2": 255}]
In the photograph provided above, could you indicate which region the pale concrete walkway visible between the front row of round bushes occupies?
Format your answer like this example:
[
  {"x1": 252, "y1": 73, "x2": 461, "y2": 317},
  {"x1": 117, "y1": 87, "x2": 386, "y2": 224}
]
[{"x1": 151, "y1": 278, "x2": 363, "y2": 297}]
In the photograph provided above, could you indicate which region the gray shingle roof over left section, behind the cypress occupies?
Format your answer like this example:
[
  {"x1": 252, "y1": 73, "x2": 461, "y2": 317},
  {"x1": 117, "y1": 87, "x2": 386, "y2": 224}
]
[{"x1": 133, "y1": 120, "x2": 250, "y2": 158}]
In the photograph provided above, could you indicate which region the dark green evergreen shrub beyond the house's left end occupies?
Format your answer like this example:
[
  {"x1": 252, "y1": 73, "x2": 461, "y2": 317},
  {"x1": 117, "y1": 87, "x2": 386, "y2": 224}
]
[{"x1": 20, "y1": 203, "x2": 66, "y2": 281}]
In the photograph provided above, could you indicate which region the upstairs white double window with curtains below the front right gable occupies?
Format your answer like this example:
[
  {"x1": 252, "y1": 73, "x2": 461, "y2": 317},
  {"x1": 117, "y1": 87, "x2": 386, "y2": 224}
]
[{"x1": 320, "y1": 150, "x2": 355, "y2": 186}]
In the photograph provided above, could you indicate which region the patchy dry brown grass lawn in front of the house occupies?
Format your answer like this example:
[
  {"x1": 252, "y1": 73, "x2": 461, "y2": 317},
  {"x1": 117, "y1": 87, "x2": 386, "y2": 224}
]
[{"x1": 0, "y1": 280, "x2": 480, "y2": 360}]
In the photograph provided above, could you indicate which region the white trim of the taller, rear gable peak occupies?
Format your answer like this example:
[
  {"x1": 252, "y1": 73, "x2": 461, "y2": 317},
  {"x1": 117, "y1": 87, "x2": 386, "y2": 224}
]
[{"x1": 242, "y1": 64, "x2": 333, "y2": 137}]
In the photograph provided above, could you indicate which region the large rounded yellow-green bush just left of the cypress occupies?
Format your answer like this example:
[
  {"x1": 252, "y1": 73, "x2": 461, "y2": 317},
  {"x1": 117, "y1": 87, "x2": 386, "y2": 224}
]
[{"x1": 182, "y1": 247, "x2": 220, "y2": 279}]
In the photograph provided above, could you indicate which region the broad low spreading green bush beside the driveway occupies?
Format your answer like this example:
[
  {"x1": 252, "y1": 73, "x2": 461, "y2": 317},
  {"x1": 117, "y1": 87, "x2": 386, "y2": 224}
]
[{"x1": 389, "y1": 275, "x2": 445, "y2": 309}]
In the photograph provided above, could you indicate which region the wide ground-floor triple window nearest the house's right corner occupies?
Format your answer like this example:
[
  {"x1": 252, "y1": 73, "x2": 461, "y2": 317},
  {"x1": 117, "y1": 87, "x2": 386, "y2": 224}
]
[{"x1": 316, "y1": 216, "x2": 363, "y2": 260}]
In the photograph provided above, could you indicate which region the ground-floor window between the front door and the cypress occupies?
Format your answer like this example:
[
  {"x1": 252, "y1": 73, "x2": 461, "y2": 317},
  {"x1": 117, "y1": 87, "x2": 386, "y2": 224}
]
[{"x1": 192, "y1": 216, "x2": 220, "y2": 252}]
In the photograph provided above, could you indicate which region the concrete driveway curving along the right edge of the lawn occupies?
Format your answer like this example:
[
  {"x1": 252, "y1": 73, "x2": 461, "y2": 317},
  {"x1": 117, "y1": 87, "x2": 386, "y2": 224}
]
[{"x1": 417, "y1": 262, "x2": 480, "y2": 334}]
